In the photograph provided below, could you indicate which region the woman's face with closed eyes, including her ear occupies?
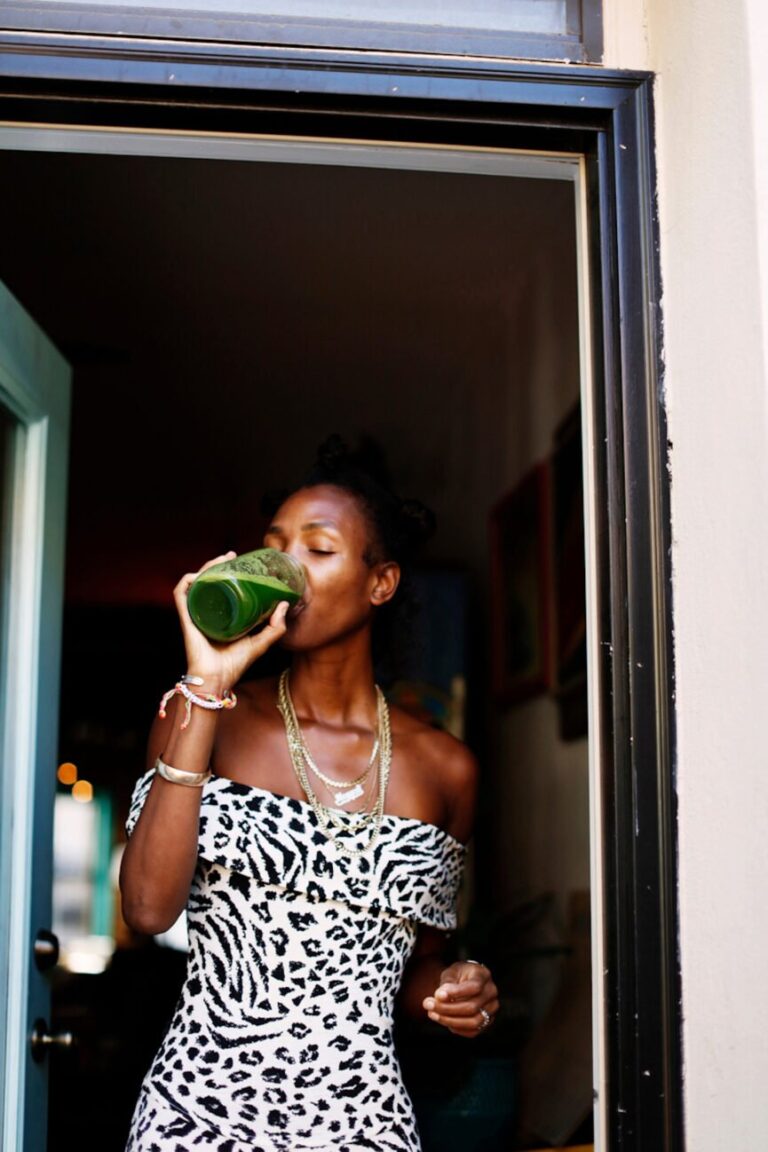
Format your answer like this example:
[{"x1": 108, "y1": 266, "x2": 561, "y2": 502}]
[{"x1": 264, "y1": 484, "x2": 400, "y2": 650}]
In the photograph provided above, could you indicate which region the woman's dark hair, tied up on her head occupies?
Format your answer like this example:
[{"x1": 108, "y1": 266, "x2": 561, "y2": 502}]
[{"x1": 263, "y1": 433, "x2": 435, "y2": 682}]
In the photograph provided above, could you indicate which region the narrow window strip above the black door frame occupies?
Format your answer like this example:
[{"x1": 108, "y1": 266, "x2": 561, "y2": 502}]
[{"x1": 0, "y1": 0, "x2": 602, "y2": 62}]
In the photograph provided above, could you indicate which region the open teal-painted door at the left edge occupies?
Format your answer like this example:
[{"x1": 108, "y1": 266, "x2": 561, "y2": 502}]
[{"x1": 0, "y1": 283, "x2": 71, "y2": 1150}]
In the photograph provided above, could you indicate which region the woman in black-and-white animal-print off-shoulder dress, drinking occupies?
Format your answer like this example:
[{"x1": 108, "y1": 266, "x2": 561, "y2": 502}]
[{"x1": 121, "y1": 446, "x2": 499, "y2": 1152}]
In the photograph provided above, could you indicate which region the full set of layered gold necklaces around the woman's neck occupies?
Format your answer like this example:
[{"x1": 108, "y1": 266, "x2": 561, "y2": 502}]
[{"x1": 277, "y1": 669, "x2": 391, "y2": 856}]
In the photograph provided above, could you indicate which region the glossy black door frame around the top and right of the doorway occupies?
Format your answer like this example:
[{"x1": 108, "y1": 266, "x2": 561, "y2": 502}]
[{"x1": 0, "y1": 31, "x2": 684, "y2": 1152}]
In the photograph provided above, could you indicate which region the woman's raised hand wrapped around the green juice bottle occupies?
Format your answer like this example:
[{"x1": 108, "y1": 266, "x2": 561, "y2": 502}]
[{"x1": 174, "y1": 552, "x2": 289, "y2": 695}]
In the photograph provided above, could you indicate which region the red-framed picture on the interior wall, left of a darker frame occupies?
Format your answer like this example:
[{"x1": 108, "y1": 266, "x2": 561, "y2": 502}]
[{"x1": 491, "y1": 463, "x2": 552, "y2": 704}]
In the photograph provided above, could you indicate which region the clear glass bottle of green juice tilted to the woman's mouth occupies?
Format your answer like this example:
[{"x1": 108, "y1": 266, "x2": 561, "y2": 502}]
[{"x1": 187, "y1": 548, "x2": 305, "y2": 642}]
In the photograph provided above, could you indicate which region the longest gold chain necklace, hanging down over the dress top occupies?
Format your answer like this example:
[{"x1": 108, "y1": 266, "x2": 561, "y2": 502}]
[{"x1": 277, "y1": 669, "x2": 391, "y2": 857}]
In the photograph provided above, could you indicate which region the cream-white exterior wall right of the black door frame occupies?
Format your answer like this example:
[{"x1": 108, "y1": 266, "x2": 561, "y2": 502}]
[{"x1": 604, "y1": 0, "x2": 768, "y2": 1152}]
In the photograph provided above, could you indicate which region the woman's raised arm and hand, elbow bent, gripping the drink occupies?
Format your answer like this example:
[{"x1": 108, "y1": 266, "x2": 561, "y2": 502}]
[{"x1": 120, "y1": 553, "x2": 288, "y2": 935}]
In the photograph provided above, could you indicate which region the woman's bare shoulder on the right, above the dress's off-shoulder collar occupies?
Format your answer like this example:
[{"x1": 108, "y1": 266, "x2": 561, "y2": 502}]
[{"x1": 391, "y1": 708, "x2": 479, "y2": 842}]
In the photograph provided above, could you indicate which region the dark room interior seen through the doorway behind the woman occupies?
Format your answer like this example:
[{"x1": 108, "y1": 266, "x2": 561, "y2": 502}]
[{"x1": 0, "y1": 151, "x2": 592, "y2": 1152}]
